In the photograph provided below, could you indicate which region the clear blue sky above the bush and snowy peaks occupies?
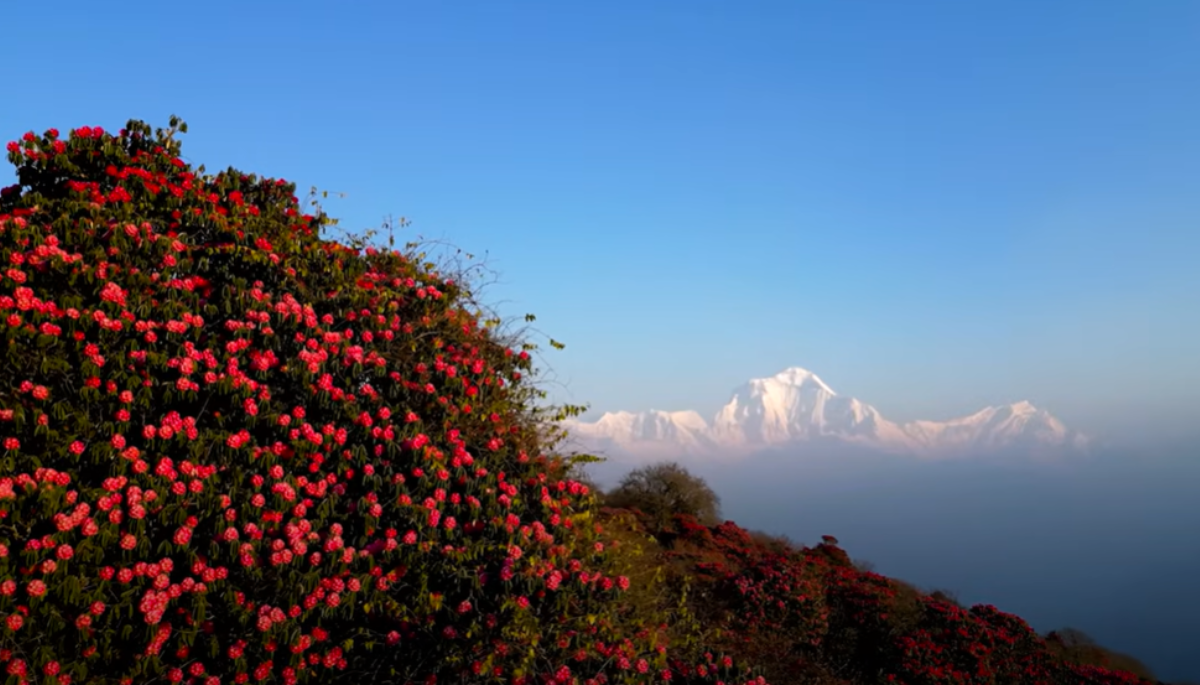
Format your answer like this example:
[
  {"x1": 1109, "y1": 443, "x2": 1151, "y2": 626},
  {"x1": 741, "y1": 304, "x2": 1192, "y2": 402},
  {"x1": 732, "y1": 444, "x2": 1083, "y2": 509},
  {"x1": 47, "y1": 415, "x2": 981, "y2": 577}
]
[{"x1": 0, "y1": 0, "x2": 1200, "y2": 439}]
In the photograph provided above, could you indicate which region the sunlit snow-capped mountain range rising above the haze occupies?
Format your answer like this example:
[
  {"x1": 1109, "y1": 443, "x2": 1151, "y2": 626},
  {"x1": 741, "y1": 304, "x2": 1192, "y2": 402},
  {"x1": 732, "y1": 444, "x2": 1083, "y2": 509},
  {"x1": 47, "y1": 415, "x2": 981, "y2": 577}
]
[{"x1": 564, "y1": 367, "x2": 1087, "y2": 456}]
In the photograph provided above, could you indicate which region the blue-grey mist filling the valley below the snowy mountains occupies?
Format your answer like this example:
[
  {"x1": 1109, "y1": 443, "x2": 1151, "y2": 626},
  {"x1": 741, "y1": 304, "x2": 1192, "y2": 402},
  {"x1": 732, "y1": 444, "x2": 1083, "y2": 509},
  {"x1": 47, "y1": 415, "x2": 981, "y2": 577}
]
[{"x1": 589, "y1": 439, "x2": 1200, "y2": 680}]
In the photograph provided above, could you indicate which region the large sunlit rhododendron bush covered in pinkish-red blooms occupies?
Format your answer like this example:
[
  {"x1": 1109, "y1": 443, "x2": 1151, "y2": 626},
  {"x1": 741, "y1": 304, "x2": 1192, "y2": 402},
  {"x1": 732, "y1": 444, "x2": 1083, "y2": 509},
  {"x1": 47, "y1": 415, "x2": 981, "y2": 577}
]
[{"x1": 0, "y1": 120, "x2": 763, "y2": 685}]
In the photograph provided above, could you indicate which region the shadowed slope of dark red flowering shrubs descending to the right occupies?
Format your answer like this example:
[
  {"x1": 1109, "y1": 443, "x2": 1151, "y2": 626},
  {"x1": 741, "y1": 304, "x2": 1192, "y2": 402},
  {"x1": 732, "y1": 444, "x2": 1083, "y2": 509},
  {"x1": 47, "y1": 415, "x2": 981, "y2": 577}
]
[{"x1": 624, "y1": 508, "x2": 1166, "y2": 685}]
